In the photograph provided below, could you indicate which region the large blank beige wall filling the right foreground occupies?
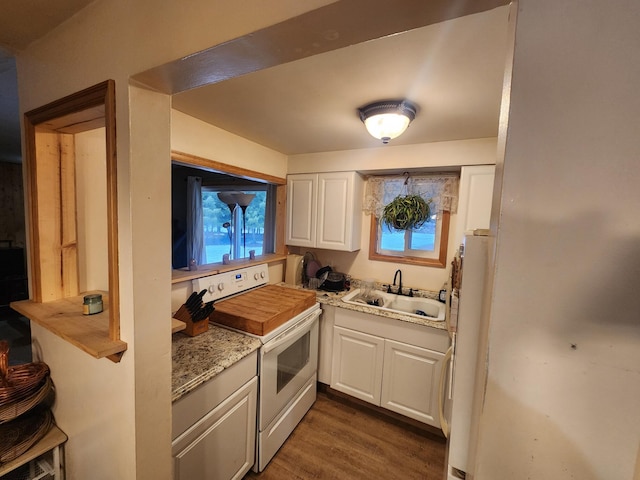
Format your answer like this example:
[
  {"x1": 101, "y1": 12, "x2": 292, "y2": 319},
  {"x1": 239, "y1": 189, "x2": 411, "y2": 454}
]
[{"x1": 475, "y1": 0, "x2": 640, "y2": 480}]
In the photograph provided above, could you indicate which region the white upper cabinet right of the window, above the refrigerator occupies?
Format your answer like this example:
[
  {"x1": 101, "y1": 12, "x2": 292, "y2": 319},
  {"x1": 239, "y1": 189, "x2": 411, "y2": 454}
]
[{"x1": 456, "y1": 165, "x2": 496, "y2": 244}]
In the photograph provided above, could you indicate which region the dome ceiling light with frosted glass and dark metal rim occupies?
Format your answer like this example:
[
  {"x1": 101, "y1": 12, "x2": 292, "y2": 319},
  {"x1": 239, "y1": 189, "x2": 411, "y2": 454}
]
[{"x1": 358, "y1": 100, "x2": 417, "y2": 144}]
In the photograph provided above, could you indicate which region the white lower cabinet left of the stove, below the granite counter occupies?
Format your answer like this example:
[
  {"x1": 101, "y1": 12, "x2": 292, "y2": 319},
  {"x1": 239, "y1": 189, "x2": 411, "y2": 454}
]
[{"x1": 172, "y1": 355, "x2": 258, "y2": 480}]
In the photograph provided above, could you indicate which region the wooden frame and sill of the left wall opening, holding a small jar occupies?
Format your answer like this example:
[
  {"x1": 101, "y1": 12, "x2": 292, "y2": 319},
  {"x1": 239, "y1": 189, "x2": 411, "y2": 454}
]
[{"x1": 20, "y1": 79, "x2": 127, "y2": 363}]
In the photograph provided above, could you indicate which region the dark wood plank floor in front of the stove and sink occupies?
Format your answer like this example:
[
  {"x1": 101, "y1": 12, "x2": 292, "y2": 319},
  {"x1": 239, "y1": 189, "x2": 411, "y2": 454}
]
[{"x1": 244, "y1": 393, "x2": 445, "y2": 480}]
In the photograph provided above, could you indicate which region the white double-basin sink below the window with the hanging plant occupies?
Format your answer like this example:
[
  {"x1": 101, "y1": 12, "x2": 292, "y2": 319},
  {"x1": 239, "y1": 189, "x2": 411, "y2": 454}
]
[{"x1": 342, "y1": 288, "x2": 445, "y2": 322}]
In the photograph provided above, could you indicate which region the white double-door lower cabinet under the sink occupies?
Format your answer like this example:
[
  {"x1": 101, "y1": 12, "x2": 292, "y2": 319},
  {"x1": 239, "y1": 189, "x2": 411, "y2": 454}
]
[{"x1": 331, "y1": 308, "x2": 449, "y2": 428}]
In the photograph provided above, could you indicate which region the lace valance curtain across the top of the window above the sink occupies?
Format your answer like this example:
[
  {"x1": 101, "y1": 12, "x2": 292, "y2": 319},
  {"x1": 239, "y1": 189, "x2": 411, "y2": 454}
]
[{"x1": 363, "y1": 173, "x2": 460, "y2": 218}]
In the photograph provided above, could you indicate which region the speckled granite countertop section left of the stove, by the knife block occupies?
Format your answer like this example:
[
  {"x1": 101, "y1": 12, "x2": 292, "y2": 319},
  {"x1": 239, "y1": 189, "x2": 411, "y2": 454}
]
[{"x1": 171, "y1": 323, "x2": 261, "y2": 402}]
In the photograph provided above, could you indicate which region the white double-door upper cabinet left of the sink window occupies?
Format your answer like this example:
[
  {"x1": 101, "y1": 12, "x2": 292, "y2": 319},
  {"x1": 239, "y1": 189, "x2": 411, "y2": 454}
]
[{"x1": 286, "y1": 172, "x2": 364, "y2": 252}]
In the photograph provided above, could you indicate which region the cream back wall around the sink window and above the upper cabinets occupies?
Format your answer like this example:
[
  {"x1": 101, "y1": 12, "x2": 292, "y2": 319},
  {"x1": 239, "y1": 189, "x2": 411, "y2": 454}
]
[{"x1": 289, "y1": 137, "x2": 497, "y2": 292}]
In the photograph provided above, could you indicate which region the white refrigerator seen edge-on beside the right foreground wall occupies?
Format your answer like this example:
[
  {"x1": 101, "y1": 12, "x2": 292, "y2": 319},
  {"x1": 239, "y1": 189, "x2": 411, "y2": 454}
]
[{"x1": 441, "y1": 230, "x2": 489, "y2": 480}]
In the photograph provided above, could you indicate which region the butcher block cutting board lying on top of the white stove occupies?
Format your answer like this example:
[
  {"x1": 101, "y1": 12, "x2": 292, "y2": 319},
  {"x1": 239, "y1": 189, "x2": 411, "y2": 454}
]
[{"x1": 209, "y1": 285, "x2": 316, "y2": 336}]
